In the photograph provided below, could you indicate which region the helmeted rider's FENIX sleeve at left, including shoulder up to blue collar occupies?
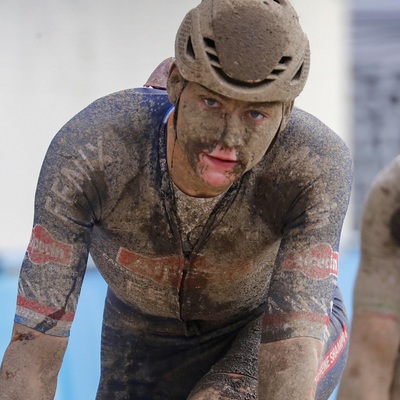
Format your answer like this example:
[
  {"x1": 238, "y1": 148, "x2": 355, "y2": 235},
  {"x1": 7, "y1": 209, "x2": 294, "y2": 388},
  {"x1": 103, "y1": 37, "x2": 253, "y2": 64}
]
[{"x1": 15, "y1": 88, "x2": 170, "y2": 336}]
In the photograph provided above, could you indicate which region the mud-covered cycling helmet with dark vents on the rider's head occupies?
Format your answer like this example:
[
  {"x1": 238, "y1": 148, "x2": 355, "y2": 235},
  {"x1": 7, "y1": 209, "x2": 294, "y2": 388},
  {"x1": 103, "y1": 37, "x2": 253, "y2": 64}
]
[{"x1": 175, "y1": 0, "x2": 310, "y2": 102}]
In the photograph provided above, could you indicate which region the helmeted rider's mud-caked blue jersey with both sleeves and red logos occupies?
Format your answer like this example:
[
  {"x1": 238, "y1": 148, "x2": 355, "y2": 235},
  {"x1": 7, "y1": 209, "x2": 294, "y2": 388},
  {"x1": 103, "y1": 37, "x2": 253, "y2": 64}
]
[{"x1": 15, "y1": 88, "x2": 352, "y2": 341}]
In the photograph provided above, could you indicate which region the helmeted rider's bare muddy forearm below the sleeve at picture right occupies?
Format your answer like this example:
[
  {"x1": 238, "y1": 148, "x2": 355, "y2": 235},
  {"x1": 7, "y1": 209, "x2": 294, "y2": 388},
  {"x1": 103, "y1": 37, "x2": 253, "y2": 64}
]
[{"x1": 258, "y1": 338, "x2": 323, "y2": 400}]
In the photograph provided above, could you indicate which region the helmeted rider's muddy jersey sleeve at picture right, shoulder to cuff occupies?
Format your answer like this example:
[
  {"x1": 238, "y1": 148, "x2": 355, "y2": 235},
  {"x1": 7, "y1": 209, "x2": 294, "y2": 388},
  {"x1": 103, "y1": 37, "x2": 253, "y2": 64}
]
[{"x1": 262, "y1": 111, "x2": 353, "y2": 342}]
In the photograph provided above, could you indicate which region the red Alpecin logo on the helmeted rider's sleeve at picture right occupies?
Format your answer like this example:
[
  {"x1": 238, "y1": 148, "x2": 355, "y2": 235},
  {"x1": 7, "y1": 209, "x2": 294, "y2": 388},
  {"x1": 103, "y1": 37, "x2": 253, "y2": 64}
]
[{"x1": 282, "y1": 243, "x2": 339, "y2": 279}]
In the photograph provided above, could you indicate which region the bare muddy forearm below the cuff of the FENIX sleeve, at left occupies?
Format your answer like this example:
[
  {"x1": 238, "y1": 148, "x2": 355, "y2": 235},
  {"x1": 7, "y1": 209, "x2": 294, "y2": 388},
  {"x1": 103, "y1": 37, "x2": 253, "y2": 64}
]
[{"x1": 0, "y1": 323, "x2": 68, "y2": 400}]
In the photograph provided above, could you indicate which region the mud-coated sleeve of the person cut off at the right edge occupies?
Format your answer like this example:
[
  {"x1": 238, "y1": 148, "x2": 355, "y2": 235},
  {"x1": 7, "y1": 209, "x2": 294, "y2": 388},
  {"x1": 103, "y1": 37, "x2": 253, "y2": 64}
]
[{"x1": 353, "y1": 156, "x2": 400, "y2": 321}]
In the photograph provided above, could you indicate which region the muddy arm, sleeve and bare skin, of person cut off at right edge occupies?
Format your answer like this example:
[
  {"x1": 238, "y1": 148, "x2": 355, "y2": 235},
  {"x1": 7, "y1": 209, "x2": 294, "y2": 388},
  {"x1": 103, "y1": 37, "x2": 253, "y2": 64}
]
[{"x1": 338, "y1": 158, "x2": 400, "y2": 400}]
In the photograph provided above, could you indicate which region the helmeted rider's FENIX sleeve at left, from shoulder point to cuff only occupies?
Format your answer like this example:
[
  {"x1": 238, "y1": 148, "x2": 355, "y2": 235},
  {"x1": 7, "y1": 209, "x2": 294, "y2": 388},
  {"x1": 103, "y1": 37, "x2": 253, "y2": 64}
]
[{"x1": 15, "y1": 98, "x2": 112, "y2": 336}]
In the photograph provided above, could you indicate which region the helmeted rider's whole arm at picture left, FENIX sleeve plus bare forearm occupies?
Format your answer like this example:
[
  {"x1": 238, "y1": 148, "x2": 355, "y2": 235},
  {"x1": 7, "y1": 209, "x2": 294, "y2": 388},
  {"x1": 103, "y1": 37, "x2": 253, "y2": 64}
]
[{"x1": 0, "y1": 96, "x2": 108, "y2": 400}]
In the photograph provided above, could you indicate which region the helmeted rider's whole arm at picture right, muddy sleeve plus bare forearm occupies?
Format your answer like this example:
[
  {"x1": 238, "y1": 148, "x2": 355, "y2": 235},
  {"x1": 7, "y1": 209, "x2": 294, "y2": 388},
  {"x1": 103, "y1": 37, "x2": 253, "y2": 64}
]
[{"x1": 259, "y1": 113, "x2": 352, "y2": 400}]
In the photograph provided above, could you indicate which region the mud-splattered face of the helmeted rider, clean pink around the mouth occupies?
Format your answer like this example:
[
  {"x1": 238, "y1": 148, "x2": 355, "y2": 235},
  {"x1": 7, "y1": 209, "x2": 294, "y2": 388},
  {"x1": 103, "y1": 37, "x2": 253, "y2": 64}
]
[{"x1": 176, "y1": 82, "x2": 282, "y2": 188}]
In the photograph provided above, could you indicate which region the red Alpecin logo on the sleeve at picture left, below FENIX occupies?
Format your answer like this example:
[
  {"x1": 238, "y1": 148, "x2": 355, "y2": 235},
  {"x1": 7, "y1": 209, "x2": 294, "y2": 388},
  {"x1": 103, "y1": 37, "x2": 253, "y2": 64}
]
[{"x1": 28, "y1": 225, "x2": 72, "y2": 266}]
